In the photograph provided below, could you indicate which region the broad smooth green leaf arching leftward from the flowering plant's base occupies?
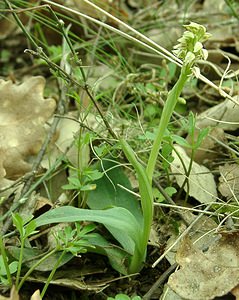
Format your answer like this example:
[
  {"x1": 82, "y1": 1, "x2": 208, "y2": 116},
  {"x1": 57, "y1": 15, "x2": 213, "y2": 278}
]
[{"x1": 35, "y1": 206, "x2": 142, "y2": 254}]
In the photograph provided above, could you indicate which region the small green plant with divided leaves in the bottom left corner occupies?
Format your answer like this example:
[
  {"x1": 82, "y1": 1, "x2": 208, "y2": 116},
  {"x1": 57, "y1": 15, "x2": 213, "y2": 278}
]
[{"x1": 0, "y1": 213, "x2": 95, "y2": 298}]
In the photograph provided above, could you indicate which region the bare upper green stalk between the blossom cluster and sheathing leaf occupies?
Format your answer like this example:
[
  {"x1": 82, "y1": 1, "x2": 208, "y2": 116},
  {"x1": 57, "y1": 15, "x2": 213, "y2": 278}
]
[{"x1": 146, "y1": 68, "x2": 188, "y2": 184}]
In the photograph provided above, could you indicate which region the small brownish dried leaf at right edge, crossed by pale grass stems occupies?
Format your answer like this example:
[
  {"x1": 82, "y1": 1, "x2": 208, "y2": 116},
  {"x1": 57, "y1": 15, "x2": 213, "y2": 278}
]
[{"x1": 218, "y1": 163, "x2": 239, "y2": 199}]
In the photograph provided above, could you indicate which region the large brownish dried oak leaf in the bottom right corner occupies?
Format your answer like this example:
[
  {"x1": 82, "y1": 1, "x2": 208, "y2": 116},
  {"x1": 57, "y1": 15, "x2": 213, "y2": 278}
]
[{"x1": 168, "y1": 231, "x2": 239, "y2": 300}]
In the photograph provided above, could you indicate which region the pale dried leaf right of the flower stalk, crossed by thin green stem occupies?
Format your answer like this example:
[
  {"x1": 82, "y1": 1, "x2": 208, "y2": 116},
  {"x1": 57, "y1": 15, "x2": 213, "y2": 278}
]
[{"x1": 171, "y1": 145, "x2": 217, "y2": 203}]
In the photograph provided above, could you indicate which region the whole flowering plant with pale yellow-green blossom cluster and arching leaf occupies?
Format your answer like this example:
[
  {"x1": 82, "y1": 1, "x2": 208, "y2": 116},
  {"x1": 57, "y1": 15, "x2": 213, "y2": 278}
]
[{"x1": 35, "y1": 22, "x2": 210, "y2": 274}]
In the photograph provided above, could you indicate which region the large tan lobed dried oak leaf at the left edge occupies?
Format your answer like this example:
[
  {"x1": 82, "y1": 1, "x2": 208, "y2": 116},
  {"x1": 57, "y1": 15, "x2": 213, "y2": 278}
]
[{"x1": 0, "y1": 76, "x2": 56, "y2": 178}]
